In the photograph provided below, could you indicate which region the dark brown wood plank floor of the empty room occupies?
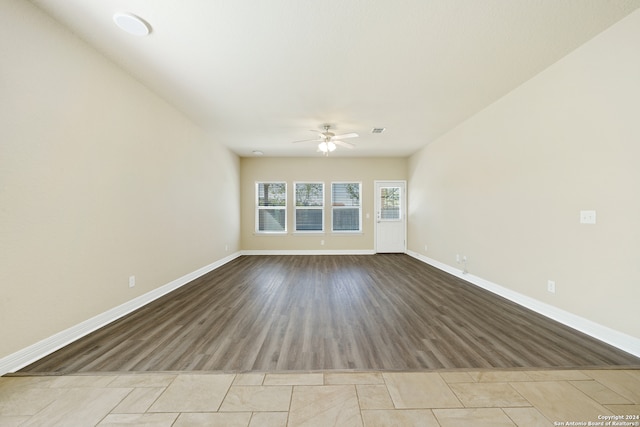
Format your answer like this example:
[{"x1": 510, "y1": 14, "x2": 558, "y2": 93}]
[{"x1": 21, "y1": 254, "x2": 640, "y2": 373}]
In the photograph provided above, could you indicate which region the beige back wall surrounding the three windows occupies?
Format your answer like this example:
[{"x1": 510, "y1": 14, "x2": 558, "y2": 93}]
[{"x1": 240, "y1": 156, "x2": 407, "y2": 251}]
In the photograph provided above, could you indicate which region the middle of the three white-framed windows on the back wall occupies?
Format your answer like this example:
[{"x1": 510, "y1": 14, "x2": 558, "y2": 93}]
[{"x1": 295, "y1": 182, "x2": 324, "y2": 232}]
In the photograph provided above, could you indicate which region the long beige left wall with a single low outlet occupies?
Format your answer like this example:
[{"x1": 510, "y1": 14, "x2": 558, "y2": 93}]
[{"x1": 0, "y1": 0, "x2": 240, "y2": 358}]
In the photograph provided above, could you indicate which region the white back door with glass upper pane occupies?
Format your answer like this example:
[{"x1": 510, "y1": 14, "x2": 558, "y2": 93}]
[{"x1": 375, "y1": 181, "x2": 407, "y2": 253}]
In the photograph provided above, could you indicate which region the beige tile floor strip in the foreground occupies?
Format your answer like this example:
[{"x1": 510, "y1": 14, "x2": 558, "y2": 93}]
[{"x1": 0, "y1": 370, "x2": 640, "y2": 427}]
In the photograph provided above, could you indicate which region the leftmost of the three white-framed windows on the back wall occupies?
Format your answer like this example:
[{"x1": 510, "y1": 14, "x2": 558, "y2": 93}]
[{"x1": 256, "y1": 182, "x2": 287, "y2": 233}]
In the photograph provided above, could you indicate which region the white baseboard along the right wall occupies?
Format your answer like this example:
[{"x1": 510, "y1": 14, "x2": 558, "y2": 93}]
[{"x1": 407, "y1": 251, "x2": 640, "y2": 357}]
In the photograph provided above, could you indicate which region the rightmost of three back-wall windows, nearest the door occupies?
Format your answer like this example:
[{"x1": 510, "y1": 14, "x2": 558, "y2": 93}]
[{"x1": 331, "y1": 182, "x2": 362, "y2": 232}]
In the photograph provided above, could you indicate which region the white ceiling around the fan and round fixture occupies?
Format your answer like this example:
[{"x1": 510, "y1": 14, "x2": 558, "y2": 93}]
[{"x1": 32, "y1": 0, "x2": 640, "y2": 156}]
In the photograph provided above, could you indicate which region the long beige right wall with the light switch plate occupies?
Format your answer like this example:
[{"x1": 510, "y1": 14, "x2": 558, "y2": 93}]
[{"x1": 409, "y1": 11, "x2": 640, "y2": 338}]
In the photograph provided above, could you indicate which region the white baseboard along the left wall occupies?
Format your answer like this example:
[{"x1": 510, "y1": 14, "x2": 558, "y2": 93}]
[{"x1": 0, "y1": 252, "x2": 242, "y2": 376}]
